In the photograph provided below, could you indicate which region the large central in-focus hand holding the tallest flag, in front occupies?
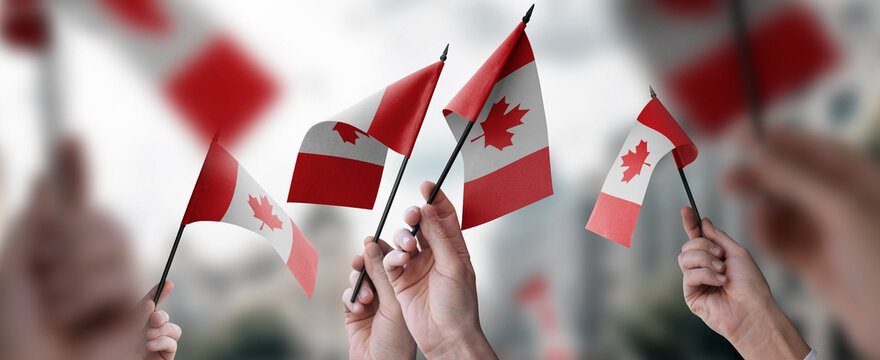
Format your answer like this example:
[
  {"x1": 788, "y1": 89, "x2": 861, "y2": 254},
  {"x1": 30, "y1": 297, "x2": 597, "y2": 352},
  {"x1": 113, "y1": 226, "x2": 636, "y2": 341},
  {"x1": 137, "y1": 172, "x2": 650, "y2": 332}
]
[{"x1": 384, "y1": 182, "x2": 497, "y2": 359}]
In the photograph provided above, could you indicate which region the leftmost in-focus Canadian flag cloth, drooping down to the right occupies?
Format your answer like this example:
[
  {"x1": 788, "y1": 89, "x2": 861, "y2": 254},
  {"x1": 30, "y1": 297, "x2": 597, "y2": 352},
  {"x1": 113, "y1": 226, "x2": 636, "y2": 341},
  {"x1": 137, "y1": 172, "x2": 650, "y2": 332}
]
[{"x1": 183, "y1": 142, "x2": 318, "y2": 299}]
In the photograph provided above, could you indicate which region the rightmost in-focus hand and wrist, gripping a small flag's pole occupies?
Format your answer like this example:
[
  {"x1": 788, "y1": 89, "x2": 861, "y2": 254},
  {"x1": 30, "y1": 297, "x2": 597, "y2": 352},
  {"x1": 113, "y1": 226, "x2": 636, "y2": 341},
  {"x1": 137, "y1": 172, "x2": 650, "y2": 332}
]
[{"x1": 678, "y1": 207, "x2": 810, "y2": 360}]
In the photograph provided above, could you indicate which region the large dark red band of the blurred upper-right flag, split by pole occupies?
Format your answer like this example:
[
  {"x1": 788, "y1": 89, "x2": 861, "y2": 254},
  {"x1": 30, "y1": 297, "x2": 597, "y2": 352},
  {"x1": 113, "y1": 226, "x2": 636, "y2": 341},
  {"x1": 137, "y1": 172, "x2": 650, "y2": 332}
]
[{"x1": 669, "y1": 4, "x2": 836, "y2": 133}]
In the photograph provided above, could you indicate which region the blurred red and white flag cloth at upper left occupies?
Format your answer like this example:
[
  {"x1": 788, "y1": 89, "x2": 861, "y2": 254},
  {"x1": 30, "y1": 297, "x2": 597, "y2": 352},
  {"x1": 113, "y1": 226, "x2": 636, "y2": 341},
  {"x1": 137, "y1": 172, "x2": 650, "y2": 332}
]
[{"x1": 55, "y1": 0, "x2": 277, "y2": 143}]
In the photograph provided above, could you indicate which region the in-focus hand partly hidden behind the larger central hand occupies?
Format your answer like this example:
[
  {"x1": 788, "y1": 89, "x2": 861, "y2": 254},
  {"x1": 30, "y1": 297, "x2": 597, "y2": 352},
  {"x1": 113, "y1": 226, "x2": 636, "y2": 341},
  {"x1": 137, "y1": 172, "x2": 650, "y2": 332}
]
[{"x1": 342, "y1": 236, "x2": 416, "y2": 360}]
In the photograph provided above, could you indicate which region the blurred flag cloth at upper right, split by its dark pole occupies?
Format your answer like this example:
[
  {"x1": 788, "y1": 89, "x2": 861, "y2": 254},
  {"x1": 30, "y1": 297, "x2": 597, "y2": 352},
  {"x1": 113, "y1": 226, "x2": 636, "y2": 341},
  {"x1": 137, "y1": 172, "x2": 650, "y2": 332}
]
[{"x1": 624, "y1": 0, "x2": 838, "y2": 134}]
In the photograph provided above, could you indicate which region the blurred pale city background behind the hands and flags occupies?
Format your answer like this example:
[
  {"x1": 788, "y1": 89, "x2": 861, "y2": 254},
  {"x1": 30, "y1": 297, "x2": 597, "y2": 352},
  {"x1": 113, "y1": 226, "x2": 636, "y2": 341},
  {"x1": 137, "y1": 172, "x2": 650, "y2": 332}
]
[{"x1": 0, "y1": 0, "x2": 880, "y2": 359}]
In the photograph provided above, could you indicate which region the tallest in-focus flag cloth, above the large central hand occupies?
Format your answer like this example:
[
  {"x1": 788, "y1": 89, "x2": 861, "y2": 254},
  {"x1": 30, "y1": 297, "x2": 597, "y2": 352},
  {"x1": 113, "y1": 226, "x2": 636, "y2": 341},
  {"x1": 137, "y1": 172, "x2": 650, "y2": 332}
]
[{"x1": 443, "y1": 23, "x2": 553, "y2": 229}]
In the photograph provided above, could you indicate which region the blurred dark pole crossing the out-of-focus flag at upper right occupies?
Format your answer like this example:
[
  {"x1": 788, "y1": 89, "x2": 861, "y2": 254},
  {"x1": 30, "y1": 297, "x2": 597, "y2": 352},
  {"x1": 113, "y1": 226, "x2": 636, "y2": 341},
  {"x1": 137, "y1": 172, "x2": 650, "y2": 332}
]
[{"x1": 728, "y1": 0, "x2": 764, "y2": 135}]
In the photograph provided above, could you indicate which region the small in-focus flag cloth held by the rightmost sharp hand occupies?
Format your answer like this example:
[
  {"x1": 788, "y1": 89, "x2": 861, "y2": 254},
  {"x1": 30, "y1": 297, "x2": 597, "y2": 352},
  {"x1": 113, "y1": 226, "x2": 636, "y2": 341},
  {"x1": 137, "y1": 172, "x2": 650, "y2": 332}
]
[{"x1": 587, "y1": 98, "x2": 697, "y2": 247}]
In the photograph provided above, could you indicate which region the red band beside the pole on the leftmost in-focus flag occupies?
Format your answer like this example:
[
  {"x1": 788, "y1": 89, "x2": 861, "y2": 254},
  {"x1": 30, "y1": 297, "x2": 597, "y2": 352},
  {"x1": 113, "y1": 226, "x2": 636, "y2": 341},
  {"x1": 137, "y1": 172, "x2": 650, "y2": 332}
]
[{"x1": 183, "y1": 143, "x2": 238, "y2": 225}]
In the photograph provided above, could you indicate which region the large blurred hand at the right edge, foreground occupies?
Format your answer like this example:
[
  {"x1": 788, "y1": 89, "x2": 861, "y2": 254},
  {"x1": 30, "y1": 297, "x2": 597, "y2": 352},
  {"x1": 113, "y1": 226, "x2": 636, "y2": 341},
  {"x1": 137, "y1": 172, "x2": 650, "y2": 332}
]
[{"x1": 727, "y1": 129, "x2": 880, "y2": 358}]
